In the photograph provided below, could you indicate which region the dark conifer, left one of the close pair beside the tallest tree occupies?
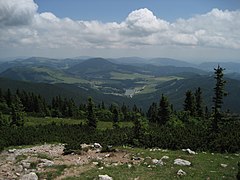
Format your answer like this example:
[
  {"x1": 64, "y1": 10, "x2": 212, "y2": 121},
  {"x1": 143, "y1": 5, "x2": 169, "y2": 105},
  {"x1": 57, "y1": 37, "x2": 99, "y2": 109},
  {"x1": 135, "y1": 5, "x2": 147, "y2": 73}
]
[{"x1": 184, "y1": 90, "x2": 196, "y2": 116}]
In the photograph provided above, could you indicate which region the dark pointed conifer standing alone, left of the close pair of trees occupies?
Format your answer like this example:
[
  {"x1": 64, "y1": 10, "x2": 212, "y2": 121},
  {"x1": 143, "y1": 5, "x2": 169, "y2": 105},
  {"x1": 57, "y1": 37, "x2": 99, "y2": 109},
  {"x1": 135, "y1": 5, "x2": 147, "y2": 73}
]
[{"x1": 158, "y1": 94, "x2": 171, "y2": 125}]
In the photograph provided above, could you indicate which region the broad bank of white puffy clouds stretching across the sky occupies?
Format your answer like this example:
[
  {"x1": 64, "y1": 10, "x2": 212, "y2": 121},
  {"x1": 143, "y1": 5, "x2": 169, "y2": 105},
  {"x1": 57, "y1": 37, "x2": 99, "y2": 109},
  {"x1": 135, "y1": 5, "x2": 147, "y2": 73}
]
[{"x1": 0, "y1": 0, "x2": 240, "y2": 56}]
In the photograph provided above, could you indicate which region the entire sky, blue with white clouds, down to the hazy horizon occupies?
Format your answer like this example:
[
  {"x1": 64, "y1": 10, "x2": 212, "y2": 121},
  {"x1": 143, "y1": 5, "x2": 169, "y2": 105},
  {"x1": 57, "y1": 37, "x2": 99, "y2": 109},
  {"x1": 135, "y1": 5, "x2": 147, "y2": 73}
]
[{"x1": 0, "y1": 0, "x2": 240, "y2": 61}]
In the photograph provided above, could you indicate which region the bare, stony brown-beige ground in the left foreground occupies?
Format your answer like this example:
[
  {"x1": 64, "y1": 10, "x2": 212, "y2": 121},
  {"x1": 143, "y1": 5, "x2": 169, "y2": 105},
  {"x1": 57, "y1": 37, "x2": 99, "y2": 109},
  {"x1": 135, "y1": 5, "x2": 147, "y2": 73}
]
[{"x1": 0, "y1": 144, "x2": 141, "y2": 180}]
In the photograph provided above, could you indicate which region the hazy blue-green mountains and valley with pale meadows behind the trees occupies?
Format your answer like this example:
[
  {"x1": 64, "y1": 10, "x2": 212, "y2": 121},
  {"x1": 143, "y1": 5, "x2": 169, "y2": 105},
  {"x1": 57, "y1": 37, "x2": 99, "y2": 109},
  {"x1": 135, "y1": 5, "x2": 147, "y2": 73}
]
[{"x1": 0, "y1": 57, "x2": 240, "y2": 112}]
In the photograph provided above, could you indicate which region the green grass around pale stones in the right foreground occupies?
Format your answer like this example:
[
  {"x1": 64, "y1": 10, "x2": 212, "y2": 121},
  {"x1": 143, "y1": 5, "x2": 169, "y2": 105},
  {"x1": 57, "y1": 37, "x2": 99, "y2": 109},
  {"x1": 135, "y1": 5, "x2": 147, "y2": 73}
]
[{"x1": 62, "y1": 148, "x2": 240, "y2": 180}]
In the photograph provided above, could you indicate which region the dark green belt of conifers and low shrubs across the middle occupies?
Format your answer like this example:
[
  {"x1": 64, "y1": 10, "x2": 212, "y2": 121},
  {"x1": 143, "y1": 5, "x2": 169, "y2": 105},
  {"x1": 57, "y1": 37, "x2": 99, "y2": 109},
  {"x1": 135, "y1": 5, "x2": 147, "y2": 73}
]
[{"x1": 0, "y1": 66, "x2": 240, "y2": 152}]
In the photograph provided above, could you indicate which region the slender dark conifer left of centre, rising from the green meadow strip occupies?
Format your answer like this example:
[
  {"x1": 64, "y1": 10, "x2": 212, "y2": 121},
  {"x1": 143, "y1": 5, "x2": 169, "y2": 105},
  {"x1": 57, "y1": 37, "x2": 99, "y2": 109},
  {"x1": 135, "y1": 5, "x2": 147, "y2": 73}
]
[{"x1": 87, "y1": 97, "x2": 97, "y2": 128}]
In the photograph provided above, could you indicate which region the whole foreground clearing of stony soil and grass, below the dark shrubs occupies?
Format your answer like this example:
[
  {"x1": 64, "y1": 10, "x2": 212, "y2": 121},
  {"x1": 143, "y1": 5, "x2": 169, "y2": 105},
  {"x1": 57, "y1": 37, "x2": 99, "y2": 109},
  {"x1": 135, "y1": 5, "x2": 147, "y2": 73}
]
[{"x1": 0, "y1": 143, "x2": 240, "y2": 180}]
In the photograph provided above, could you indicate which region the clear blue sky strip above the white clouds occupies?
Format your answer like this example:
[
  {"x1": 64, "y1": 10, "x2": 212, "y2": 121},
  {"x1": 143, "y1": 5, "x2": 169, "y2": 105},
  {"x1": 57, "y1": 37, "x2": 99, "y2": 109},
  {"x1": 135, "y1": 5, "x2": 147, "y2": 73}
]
[{"x1": 35, "y1": 0, "x2": 240, "y2": 22}]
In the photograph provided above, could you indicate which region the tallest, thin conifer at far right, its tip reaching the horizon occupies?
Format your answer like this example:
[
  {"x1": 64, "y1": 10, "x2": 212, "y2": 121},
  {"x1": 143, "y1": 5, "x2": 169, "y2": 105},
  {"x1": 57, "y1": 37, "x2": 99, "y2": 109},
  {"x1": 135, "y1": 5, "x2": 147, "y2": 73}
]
[{"x1": 212, "y1": 65, "x2": 227, "y2": 131}]
